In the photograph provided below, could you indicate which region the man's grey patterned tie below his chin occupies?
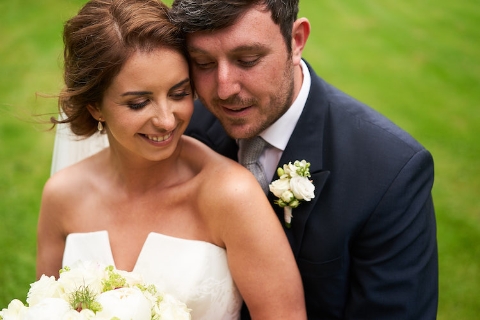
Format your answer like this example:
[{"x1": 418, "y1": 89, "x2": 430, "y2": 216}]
[{"x1": 238, "y1": 136, "x2": 268, "y2": 194}]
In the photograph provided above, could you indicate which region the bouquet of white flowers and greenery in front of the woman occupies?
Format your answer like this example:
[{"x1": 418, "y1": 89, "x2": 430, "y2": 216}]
[{"x1": 0, "y1": 262, "x2": 191, "y2": 320}]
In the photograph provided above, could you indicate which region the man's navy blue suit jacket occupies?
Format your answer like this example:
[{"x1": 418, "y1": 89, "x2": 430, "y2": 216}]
[{"x1": 187, "y1": 61, "x2": 438, "y2": 320}]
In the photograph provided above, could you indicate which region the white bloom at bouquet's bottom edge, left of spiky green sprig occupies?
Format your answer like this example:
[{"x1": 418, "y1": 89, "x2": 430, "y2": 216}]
[{"x1": 22, "y1": 298, "x2": 72, "y2": 320}]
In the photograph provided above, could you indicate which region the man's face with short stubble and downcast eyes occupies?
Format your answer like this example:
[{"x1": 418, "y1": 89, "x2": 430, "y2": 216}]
[{"x1": 187, "y1": 7, "x2": 294, "y2": 138}]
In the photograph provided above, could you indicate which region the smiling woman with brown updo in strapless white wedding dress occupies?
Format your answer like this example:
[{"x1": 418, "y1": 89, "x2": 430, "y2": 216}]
[{"x1": 37, "y1": 0, "x2": 306, "y2": 319}]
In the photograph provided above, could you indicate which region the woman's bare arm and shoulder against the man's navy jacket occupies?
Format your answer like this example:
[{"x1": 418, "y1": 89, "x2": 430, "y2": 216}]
[{"x1": 205, "y1": 167, "x2": 306, "y2": 320}]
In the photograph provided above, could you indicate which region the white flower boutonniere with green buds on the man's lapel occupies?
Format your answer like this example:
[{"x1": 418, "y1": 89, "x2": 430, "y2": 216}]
[{"x1": 269, "y1": 160, "x2": 315, "y2": 228}]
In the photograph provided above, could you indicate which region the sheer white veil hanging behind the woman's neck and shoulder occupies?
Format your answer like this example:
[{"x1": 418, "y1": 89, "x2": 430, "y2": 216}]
[{"x1": 51, "y1": 116, "x2": 108, "y2": 175}]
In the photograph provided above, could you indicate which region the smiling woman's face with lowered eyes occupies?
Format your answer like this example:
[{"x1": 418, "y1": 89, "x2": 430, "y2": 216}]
[{"x1": 94, "y1": 48, "x2": 193, "y2": 161}]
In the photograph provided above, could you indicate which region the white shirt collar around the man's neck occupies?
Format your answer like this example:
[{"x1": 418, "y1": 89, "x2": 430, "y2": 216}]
[{"x1": 260, "y1": 60, "x2": 311, "y2": 151}]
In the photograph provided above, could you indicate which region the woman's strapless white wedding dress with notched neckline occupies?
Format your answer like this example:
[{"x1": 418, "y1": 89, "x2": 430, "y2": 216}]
[{"x1": 63, "y1": 231, "x2": 242, "y2": 320}]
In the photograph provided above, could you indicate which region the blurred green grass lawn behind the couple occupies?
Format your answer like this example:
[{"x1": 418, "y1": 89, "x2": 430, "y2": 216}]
[{"x1": 0, "y1": 0, "x2": 480, "y2": 320}]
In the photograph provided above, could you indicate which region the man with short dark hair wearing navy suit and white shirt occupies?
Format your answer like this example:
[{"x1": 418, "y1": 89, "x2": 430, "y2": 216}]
[{"x1": 171, "y1": 0, "x2": 438, "y2": 320}]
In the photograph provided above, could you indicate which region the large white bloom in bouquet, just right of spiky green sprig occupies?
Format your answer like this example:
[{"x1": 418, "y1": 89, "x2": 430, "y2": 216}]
[{"x1": 97, "y1": 287, "x2": 152, "y2": 320}]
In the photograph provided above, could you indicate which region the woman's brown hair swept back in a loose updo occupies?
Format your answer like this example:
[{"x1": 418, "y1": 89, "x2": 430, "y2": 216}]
[{"x1": 51, "y1": 0, "x2": 186, "y2": 137}]
